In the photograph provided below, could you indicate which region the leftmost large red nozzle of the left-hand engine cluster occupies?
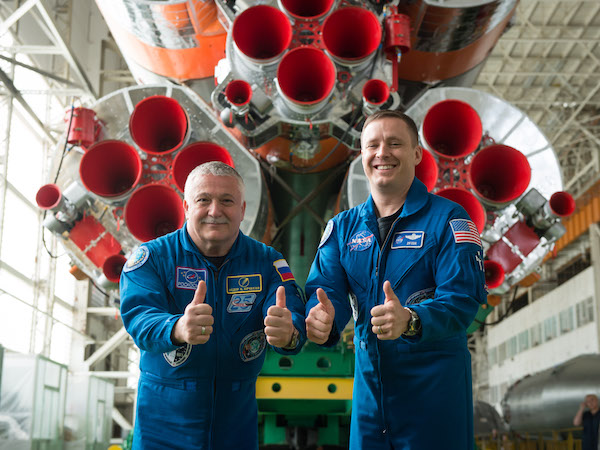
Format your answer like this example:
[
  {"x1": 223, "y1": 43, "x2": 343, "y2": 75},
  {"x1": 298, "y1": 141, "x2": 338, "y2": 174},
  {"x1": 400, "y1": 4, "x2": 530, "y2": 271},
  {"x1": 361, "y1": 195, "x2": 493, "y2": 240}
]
[{"x1": 79, "y1": 140, "x2": 142, "y2": 197}]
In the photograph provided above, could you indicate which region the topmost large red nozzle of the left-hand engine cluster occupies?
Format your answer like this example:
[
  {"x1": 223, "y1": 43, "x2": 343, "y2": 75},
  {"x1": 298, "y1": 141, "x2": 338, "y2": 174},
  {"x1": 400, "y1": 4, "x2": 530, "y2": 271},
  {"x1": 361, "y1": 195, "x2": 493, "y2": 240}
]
[{"x1": 129, "y1": 95, "x2": 188, "y2": 155}]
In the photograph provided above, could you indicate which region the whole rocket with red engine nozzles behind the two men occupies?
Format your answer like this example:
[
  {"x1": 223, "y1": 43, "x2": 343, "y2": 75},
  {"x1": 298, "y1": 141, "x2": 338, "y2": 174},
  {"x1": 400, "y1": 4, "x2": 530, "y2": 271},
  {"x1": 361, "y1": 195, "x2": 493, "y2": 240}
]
[{"x1": 37, "y1": 0, "x2": 574, "y2": 306}]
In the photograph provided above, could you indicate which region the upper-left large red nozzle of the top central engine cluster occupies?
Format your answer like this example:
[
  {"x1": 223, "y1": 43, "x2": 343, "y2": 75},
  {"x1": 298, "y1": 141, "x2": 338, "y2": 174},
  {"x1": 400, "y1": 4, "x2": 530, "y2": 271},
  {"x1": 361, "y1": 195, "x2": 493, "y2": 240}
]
[{"x1": 231, "y1": 5, "x2": 292, "y2": 64}]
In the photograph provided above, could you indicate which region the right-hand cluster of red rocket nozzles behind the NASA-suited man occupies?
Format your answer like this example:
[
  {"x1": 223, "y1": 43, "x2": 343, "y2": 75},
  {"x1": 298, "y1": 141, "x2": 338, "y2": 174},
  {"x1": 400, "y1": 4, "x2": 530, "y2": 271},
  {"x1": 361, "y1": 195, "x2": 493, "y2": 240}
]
[{"x1": 416, "y1": 99, "x2": 575, "y2": 289}]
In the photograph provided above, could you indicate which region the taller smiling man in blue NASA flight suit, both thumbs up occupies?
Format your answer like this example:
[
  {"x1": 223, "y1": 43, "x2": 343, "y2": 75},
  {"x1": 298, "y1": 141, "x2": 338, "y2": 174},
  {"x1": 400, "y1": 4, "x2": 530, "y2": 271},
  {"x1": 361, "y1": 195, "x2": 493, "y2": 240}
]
[{"x1": 306, "y1": 111, "x2": 486, "y2": 450}]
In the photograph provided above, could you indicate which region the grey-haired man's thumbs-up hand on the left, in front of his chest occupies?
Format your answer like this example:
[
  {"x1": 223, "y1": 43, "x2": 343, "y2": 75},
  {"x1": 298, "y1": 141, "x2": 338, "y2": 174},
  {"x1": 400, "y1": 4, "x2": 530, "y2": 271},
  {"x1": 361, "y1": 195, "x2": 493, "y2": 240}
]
[{"x1": 171, "y1": 280, "x2": 215, "y2": 345}]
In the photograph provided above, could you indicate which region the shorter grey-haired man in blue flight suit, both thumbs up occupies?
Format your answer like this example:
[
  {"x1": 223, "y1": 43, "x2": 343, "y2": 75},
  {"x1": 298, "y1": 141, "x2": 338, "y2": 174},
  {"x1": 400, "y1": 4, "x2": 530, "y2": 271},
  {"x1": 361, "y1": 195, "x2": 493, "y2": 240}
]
[{"x1": 121, "y1": 162, "x2": 305, "y2": 450}]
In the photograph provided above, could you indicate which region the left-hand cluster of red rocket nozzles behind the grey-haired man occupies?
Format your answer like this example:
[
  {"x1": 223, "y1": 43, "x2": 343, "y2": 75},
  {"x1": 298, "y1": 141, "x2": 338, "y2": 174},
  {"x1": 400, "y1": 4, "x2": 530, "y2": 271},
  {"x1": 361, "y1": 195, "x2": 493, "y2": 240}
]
[{"x1": 36, "y1": 96, "x2": 234, "y2": 283}]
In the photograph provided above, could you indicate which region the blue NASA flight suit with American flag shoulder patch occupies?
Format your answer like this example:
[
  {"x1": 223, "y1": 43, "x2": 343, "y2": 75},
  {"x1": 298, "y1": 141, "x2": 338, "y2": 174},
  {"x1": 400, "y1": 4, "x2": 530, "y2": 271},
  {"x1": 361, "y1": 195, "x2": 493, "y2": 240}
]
[{"x1": 306, "y1": 178, "x2": 487, "y2": 450}]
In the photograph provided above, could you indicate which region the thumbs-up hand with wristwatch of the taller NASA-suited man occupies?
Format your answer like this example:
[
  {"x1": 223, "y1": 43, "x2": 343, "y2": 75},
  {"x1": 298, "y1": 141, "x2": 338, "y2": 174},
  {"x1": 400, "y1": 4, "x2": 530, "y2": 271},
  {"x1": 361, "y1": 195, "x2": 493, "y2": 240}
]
[{"x1": 371, "y1": 281, "x2": 411, "y2": 340}]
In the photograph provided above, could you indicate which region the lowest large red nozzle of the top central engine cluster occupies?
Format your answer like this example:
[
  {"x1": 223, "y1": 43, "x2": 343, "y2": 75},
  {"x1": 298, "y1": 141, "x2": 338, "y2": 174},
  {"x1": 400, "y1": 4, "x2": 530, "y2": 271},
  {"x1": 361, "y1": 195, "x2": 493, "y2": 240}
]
[{"x1": 277, "y1": 47, "x2": 335, "y2": 106}]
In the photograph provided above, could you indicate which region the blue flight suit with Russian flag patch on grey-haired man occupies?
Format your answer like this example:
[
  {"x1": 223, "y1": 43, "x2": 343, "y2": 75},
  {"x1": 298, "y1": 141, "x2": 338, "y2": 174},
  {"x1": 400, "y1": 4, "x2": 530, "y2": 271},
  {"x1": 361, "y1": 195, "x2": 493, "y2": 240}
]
[{"x1": 121, "y1": 225, "x2": 305, "y2": 450}]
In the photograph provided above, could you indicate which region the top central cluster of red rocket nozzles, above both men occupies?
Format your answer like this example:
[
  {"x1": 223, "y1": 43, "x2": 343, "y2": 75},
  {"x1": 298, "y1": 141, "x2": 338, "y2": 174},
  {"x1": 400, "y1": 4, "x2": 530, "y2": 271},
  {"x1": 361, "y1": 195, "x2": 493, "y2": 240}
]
[{"x1": 224, "y1": 0, "x2": 410, "y2": 115}]
